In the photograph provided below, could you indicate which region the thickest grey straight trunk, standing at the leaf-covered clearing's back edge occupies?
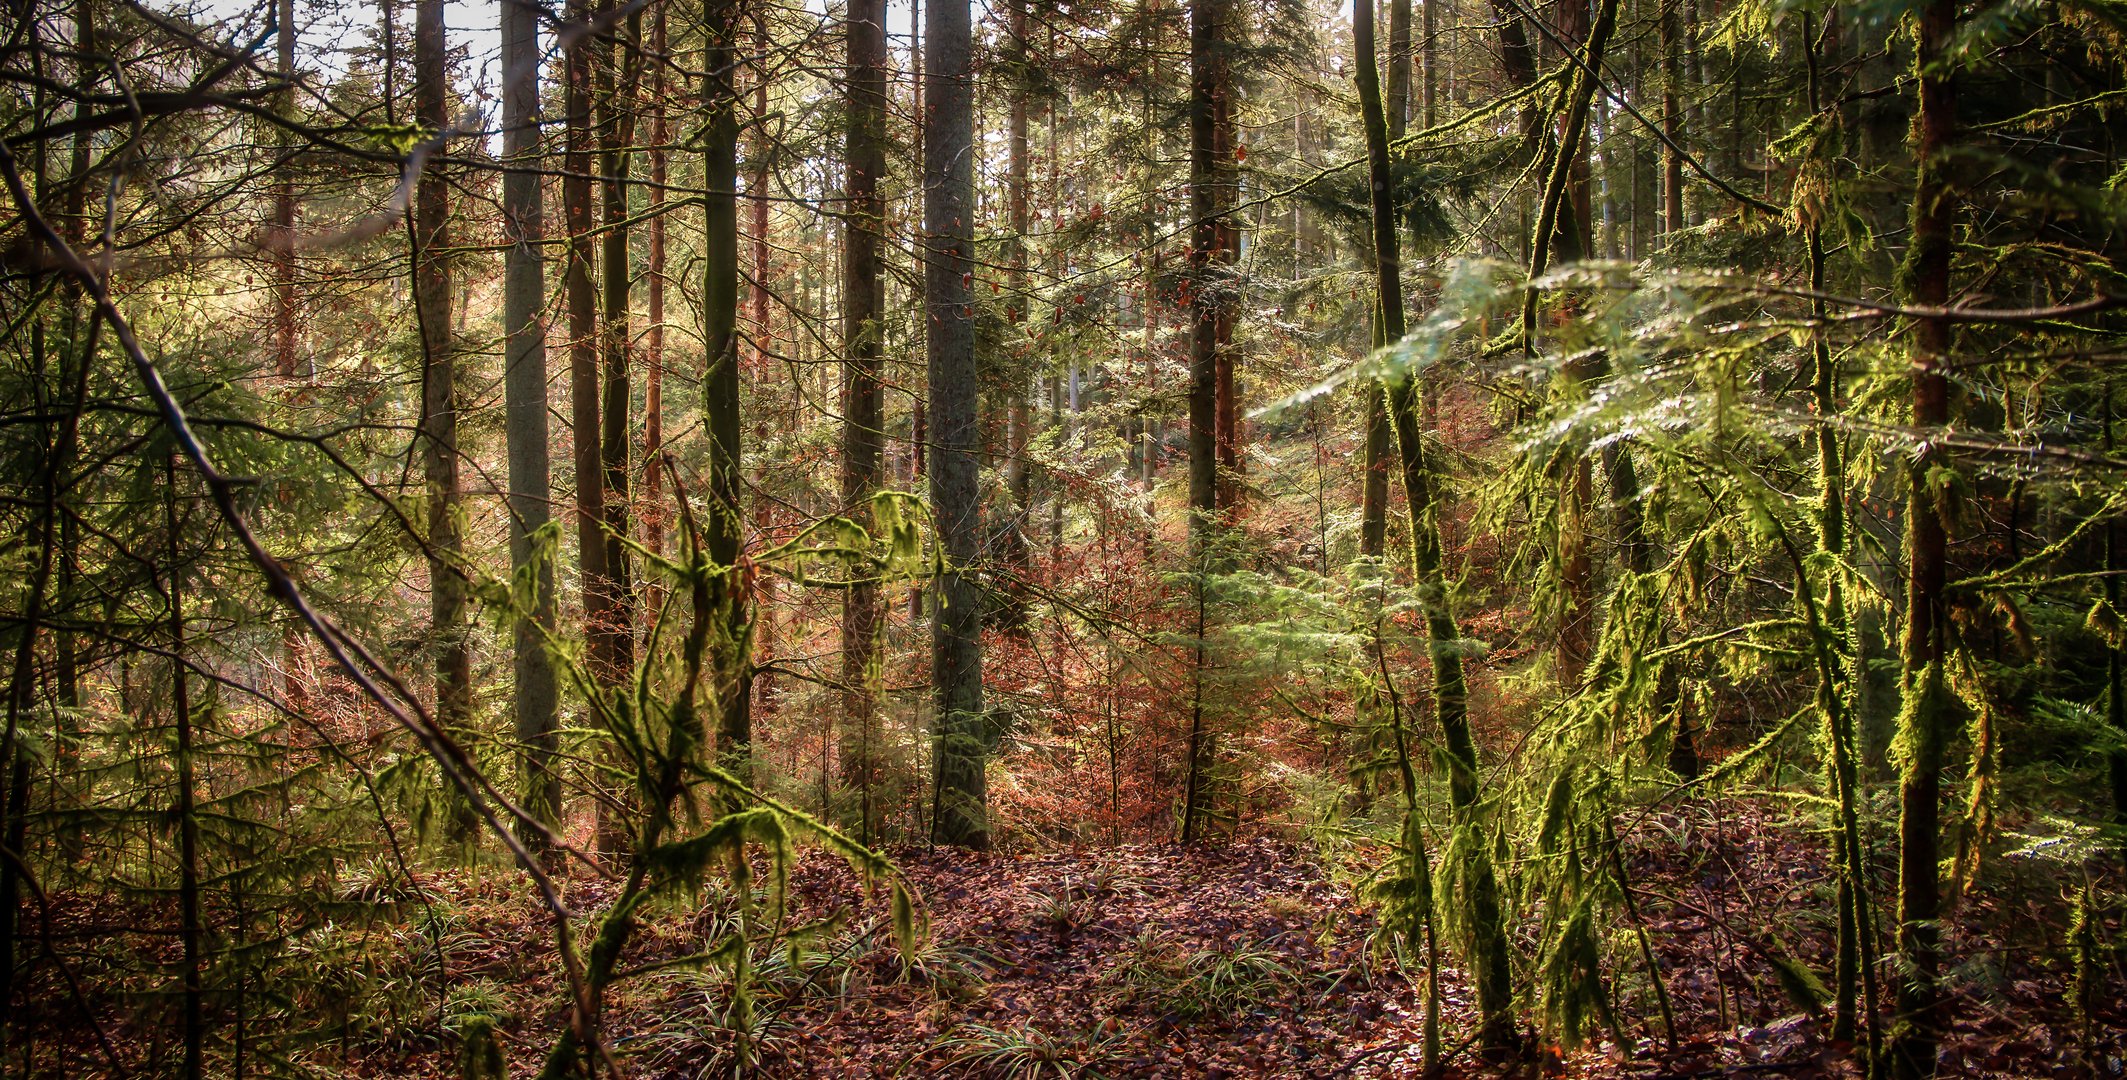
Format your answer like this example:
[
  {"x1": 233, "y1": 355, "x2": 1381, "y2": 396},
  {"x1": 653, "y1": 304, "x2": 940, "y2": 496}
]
[{"x1": 923, "y1": 2, "x2": 989, "y2": 848}]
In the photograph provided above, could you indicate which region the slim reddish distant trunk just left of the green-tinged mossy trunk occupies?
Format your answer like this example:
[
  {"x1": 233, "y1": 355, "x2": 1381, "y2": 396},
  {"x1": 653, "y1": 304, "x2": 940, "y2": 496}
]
[{"x1": 636, "y1": 4, "x2": 672, "y2": 591}]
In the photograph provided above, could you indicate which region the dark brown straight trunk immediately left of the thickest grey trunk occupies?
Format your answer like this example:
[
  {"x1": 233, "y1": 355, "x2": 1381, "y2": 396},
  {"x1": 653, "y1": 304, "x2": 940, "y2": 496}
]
[{"x1": 840, "y1": 0, "x2": 889, "y2": 844}]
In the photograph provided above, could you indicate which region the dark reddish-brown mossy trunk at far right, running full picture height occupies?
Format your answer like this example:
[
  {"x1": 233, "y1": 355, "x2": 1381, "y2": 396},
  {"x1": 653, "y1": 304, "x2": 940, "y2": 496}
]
[{"x1": 1891, "y1": 0, "x2": 1957, "y2": 1080}]
